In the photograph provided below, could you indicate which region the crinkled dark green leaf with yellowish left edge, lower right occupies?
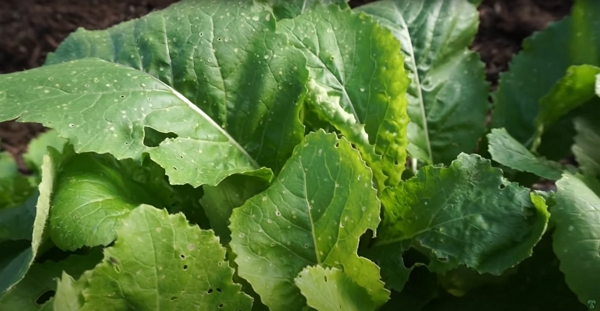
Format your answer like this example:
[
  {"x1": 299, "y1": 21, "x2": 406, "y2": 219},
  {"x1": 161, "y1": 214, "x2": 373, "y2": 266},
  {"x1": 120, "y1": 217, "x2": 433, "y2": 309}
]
[{"x1": 376, "y1": 154, "x2": 549, "y2": 274}]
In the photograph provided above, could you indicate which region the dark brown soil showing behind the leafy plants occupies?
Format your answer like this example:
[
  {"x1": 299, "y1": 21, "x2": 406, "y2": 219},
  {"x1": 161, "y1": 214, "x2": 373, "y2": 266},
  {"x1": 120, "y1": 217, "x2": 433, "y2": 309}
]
[{"x1": 0, "y1": 0, "x2": 571, "y2": 171}]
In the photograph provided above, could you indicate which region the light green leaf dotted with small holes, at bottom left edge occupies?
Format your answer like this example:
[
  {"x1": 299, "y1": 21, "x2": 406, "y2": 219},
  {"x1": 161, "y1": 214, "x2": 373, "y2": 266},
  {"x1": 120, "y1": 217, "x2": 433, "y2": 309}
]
[{"x1": 55, "y1": 205, "x2": 252, "y2": 311}]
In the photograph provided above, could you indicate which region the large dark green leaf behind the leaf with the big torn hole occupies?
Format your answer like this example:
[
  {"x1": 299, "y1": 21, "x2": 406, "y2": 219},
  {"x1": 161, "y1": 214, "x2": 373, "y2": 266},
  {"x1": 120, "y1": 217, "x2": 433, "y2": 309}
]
[{"x1": 47, "y1": 0, "x2": 307, "y2": 174}]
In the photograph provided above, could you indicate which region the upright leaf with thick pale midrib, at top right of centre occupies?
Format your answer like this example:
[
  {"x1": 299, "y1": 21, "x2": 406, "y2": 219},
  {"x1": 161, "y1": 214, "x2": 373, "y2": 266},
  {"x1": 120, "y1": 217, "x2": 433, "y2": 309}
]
[{"x1": 356, "y1": 0, "x2": 488, "y2": 164}]
